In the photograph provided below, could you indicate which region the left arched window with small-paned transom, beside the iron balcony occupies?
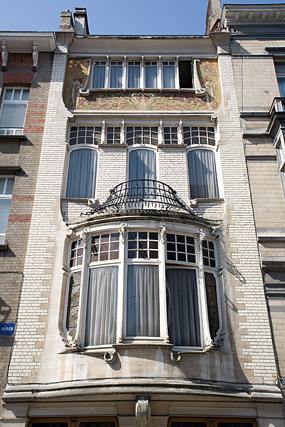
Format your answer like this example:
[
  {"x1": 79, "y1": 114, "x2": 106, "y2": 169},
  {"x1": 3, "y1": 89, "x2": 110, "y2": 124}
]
[{"x1": 66, "y1": 126, "x2": 98, "y2": 199}]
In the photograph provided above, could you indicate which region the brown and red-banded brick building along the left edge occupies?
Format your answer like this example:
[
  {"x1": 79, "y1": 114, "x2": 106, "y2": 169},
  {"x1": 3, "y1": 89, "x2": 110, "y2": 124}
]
[{"x1": 0, "y1": 32, "x2": 55, "y2": 416}]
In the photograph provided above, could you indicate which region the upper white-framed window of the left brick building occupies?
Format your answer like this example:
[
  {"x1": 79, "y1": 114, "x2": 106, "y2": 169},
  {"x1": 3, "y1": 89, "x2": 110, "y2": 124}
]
[{"x1": 0, "y1": 88, "x2": 29, "y2": 135}]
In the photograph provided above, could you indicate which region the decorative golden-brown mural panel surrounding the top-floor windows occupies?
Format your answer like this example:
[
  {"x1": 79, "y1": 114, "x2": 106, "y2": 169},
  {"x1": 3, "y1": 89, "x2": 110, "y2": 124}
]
[{"x1": 63, "y1": 59, "x2": 221, "y2": 111}]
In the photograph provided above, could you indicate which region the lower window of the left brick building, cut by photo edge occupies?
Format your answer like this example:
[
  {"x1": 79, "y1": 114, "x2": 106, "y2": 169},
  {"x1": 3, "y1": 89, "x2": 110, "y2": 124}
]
[{"x1": 0, "y1": 177, "x2": 14, "y2": 245}]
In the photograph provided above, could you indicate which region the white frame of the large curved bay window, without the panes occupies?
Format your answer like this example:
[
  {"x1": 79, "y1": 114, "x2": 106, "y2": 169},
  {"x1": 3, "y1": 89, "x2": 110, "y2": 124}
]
[{"x1": 65, "y1": 222, "x2": 222, "y2": 353}]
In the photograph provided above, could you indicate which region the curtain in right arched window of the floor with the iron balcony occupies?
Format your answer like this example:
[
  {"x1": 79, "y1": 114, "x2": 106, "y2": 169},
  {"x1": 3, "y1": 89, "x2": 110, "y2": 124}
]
[{"x1": 188, "y1": 150, "x2": 219, "y2": 199}]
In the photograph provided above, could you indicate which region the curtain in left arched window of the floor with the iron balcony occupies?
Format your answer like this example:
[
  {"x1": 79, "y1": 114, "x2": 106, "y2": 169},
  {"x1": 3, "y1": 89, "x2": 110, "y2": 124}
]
[{"x1": 66, "y1": 148, "x2": 97, "y2": 199}]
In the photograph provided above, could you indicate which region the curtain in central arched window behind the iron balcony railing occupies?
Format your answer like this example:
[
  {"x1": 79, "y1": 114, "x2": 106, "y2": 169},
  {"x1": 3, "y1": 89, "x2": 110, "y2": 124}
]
[{"x1": 129, "y1": 149, "x2": 156, "y2": 198}]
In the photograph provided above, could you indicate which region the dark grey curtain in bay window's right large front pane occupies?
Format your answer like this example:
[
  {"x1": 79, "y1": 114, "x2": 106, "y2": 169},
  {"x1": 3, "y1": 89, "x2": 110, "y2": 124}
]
[{"x1": 166, "y1": 268, "x2": 201, "y2": 347}]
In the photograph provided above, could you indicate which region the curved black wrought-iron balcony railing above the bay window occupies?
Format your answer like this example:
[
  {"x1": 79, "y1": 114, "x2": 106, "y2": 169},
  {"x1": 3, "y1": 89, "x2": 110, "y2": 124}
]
[{"x1": 86, "y1": 179, "x2": 194, "y2": 215}]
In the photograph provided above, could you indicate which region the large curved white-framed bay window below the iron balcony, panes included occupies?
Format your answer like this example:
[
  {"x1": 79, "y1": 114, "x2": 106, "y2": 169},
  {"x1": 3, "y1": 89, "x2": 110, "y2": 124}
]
[{"x1": 66, "y1": 223, "x2": 221, "y2": 351}]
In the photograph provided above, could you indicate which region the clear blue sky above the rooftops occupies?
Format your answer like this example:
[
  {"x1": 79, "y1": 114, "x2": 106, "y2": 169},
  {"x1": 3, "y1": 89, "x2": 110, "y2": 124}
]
[{"x1": 0, "y1": 0, "x2": 285, "y2": 35}]
